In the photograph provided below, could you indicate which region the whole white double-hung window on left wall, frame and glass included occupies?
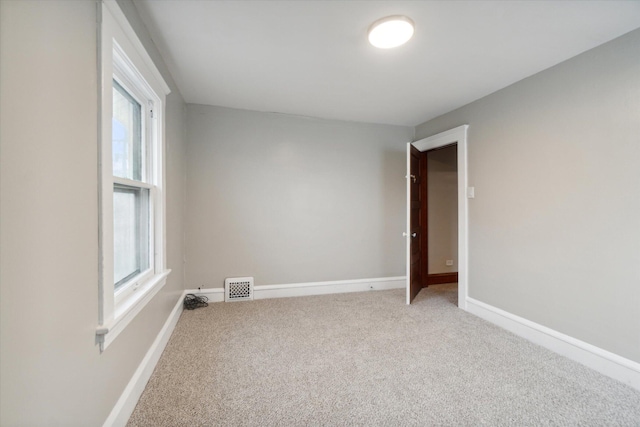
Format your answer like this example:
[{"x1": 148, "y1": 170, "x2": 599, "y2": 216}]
[{"x1": 97, "y1": 0, "x2": 169, "y2": 351}]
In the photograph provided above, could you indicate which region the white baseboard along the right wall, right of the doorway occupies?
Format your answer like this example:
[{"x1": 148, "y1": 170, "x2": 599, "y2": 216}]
[{"x1": 467, "y1": 297, "x2": 640, "y2": 390}]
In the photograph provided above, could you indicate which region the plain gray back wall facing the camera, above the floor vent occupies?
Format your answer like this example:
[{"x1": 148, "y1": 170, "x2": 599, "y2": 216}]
[{"x1": 186, "y1": 105, "x2": 413, "y2": 288}]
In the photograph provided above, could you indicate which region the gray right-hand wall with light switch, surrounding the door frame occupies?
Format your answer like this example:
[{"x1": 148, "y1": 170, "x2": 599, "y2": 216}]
[{"x1": 416, "y1": 30, "x2": 640, "y2": 362}]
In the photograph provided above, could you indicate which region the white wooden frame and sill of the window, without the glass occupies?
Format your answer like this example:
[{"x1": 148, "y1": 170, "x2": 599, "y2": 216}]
[{"x1": 96, "y1": 0, "x2": 171, "y2": 352}]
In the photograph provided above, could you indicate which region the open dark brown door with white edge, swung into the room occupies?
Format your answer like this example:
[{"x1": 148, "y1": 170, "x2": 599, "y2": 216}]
[{"x1": 404, "y1": 143, "x2": 424, "y2": 304}]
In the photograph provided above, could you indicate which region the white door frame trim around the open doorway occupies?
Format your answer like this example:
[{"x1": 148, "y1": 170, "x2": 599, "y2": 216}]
[{"x1": 405, "y1": 125, "x2": 469, "y2": 310}]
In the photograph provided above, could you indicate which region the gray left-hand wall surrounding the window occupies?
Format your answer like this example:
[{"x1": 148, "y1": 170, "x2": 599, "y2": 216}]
[{"x1": 0, "y1": 0, "x2": 186, "y2": 426}]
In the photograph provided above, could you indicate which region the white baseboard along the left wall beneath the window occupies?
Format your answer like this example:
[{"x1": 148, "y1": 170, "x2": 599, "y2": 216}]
[{"x1": 103, "y1": 293, "x2": 185, "y2": 427}]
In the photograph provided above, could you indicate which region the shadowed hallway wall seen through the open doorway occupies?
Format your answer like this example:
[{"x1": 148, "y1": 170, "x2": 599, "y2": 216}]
[{"x1": 427, "y1": 146, "x2": 458, "y2": 274}]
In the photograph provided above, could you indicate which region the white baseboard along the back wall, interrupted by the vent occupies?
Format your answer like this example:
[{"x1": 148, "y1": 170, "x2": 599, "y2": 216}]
[{"x1": 187, "y1": 276, "x2": 406, "y2": 302}]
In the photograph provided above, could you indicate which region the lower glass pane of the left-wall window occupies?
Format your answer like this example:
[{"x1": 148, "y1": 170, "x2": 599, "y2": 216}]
[{"x1": 113, "y1": 185, "x2": 149, "y2": 289}]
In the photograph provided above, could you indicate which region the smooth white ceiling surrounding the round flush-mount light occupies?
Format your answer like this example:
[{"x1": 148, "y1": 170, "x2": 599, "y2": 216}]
[{"x1": 134, "y1": 0, "x2": 640, "y2": 126}]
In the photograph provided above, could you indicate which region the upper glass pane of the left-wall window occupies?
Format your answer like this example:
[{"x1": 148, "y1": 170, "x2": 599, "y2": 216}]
[{"x1": 111, "y1": 80, "x2": 144, "y2": 181}]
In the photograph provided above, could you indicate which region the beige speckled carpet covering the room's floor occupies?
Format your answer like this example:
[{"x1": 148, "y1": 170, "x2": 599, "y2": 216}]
[{"x1": 128, "y1": 285, "x2": 640, "y2": 426}]
